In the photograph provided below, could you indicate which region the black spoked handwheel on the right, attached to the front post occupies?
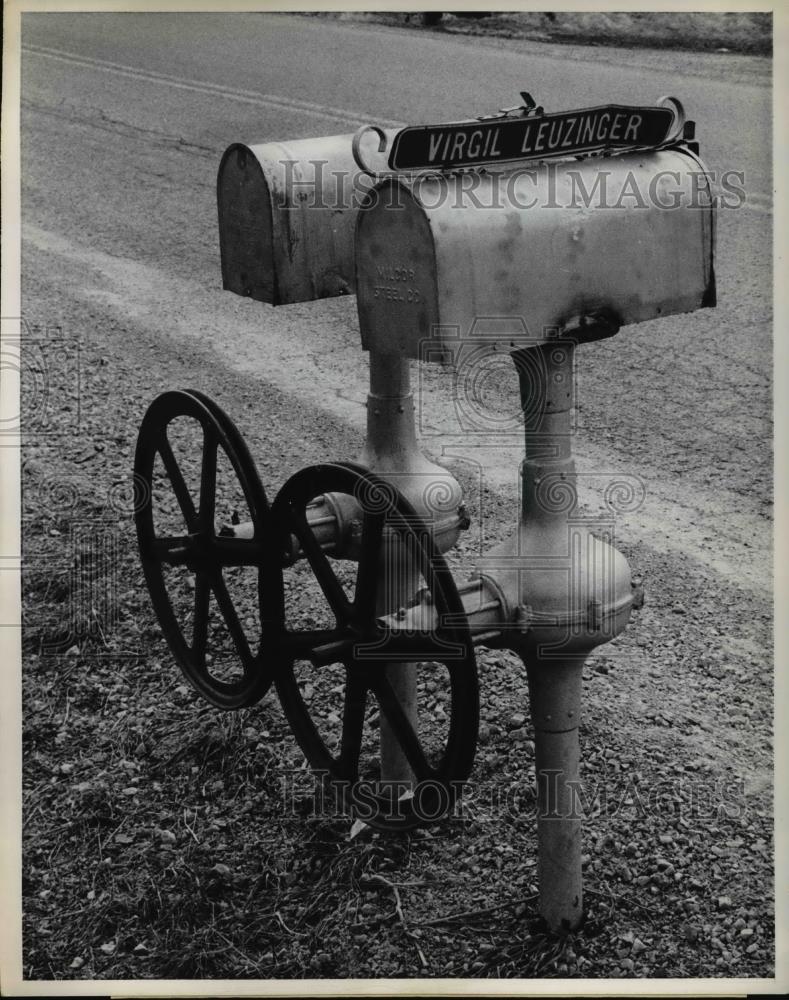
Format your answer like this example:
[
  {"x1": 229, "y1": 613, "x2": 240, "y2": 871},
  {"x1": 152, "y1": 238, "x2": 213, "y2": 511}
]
[{"x1": 265, "y1": 463, "x2": 479, "y2": 829}]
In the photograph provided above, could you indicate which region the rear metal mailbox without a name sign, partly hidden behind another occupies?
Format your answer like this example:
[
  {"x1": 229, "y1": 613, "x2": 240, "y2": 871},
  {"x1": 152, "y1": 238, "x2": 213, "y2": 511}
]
[{"x1": 217, "y1": 135, "x2": 394, "y2": 305}]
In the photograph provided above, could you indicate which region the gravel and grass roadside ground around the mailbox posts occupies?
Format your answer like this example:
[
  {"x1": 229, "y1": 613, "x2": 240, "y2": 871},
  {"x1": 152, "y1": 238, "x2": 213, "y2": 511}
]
[{"x1": 22, "y1": 232, "x2": 774, "y2": 979}]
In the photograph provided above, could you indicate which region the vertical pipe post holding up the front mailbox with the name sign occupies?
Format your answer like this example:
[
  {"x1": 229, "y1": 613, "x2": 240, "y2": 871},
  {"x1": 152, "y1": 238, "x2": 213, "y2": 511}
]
[{"x1": 514, "y1": 341, "x2": 595, "y2": 932}]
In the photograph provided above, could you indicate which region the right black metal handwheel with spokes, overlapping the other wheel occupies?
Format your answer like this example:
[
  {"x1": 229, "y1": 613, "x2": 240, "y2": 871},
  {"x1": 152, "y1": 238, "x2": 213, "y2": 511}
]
[{"x1": 264, "y1": 463, "x2": 479, "y2": 829}]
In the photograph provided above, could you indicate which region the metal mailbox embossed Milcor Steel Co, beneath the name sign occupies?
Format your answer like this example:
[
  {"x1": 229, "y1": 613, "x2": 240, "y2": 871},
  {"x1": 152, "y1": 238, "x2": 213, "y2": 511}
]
[{"x1": 355, "y1": 147, "x2": 715, "y2": 361}]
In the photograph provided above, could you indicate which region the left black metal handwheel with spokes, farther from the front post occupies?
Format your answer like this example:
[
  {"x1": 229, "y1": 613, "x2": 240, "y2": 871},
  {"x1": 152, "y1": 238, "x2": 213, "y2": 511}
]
[{"x1": 134, "y1": 390, "x2": 281, "y2": 709}]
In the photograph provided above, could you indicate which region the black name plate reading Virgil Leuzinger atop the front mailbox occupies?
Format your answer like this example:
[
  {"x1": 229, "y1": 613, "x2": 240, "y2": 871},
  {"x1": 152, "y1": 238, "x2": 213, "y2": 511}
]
[{"x1": 389, "y1": 104, "x2": 674, "y2": 170}]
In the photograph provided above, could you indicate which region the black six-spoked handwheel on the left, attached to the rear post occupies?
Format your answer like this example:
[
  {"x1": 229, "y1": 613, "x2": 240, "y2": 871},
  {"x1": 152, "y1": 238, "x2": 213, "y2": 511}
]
[{"x1": 134, "y1": 390, "x2": 282, "y2": 709}]
